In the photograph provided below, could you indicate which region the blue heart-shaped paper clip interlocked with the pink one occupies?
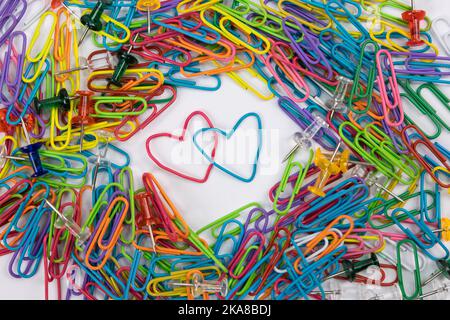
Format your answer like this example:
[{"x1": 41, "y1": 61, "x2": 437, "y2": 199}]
[{"x1": 192, "y1": 112, "x2": 262, "y2": 182}]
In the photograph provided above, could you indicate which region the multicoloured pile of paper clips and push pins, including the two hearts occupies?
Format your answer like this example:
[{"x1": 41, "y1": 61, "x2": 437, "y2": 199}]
[{"x1": 0, "y1": 0, "x2": 450, "y2": 300}]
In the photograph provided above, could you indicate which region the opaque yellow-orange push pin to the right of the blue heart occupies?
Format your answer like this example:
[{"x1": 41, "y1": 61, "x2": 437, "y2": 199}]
[{"x1": 308, "y1": 141, "x2": 349, "y2": 197}]
